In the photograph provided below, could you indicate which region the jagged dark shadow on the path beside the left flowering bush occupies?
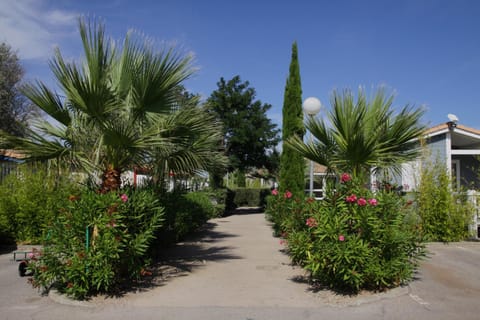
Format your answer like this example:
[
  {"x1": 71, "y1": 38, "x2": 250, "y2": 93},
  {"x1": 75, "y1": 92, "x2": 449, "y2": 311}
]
[{"x1": 104, "y1": 222, "x2": 242, "y2": 298}]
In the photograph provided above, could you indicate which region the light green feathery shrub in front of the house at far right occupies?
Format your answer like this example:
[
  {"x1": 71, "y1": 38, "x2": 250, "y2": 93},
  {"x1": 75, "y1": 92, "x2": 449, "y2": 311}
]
[{"x1": 416, "y1": 160, "x2": 474, "y2": 242}]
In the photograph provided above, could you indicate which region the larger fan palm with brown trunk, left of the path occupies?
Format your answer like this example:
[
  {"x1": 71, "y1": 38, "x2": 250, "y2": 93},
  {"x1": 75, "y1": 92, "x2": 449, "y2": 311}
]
[{"x1": 5, "y1": 20, "x2": 225, "y2": 192}]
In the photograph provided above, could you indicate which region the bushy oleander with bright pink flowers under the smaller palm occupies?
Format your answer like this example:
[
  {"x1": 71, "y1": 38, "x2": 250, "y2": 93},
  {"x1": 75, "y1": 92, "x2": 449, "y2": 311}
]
[{"x1": 266, "y1": 175, "x2": 425, "y2": 292}]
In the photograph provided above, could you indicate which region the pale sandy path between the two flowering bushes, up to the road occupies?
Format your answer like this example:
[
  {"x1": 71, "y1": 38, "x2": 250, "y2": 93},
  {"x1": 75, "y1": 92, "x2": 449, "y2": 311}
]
[{"x1": 117, "y1": 214, "x2": 318, "y2": 307}]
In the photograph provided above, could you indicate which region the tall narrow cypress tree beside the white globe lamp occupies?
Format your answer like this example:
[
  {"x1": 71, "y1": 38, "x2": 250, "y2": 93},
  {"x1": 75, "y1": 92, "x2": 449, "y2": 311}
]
[{"x1": 279, "y1": 42, "x2": 305, "y2": 194}]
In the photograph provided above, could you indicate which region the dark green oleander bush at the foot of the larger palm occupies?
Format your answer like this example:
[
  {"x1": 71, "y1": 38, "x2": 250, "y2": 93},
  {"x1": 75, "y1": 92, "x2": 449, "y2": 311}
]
[{"x1": 29, "y1": 190, "x2": 163, "y2": 299}]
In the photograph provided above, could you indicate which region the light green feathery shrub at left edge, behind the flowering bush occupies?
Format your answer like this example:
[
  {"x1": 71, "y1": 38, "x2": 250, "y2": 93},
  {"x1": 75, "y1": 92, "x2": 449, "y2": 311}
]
[{"x1": 0, "y1": 165, "x2": 78, "y2": 243}]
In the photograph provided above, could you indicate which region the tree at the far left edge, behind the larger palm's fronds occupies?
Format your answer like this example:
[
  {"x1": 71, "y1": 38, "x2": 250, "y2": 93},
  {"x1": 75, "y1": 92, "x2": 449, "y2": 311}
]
[{"x1": 0, "y1": 43, "x2": 32, "y2": 136}]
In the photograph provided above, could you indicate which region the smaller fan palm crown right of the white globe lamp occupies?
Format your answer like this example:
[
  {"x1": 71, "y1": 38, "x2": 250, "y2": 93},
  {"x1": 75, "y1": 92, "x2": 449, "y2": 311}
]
[{"x1": 285, "y1": 89, "x2": 425, "y2": 178}]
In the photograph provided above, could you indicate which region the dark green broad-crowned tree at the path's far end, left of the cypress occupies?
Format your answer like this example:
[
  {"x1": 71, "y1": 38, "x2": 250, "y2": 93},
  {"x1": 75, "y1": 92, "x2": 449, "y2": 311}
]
[{"x1": 206, "y1": 75, "x2": 279, "y2": 184}]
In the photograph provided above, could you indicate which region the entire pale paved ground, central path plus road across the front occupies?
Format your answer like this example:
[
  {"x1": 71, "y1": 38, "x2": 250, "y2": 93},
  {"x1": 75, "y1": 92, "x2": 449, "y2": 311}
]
[{"x1": 0, "y1": 214, "x2": 480, "y2": 320}]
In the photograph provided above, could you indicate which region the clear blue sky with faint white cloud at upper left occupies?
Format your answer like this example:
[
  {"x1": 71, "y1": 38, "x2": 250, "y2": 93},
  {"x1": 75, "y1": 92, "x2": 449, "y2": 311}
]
[{"x1": 0, "y1": 0, "x2": 480, "y2": 128}]
